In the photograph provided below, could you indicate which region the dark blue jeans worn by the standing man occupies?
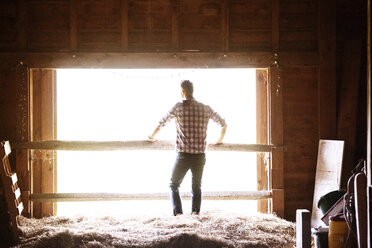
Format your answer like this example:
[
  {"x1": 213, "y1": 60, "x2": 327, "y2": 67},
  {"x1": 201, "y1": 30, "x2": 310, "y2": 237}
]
[{"x1": 170, "y1": 152, "x2": 205, "y2": 215}]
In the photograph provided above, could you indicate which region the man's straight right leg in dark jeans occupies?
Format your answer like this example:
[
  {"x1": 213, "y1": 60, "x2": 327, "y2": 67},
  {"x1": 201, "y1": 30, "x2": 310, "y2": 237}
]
[{"x1": 191, "y1": 154, "x2": 205, "y2": 214}]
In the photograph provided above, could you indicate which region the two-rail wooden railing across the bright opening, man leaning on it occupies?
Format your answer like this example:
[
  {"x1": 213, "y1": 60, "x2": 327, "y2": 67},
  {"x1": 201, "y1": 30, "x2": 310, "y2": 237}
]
[{"x1": 13, "y1": 140, "x2": 277, "y2": 202}]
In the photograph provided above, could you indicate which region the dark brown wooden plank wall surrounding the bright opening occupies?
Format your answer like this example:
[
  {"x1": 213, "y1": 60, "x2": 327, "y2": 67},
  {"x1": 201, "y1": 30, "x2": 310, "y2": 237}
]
[{"x1": 0, "y1": 0, "x2": 367, "y2": 234}]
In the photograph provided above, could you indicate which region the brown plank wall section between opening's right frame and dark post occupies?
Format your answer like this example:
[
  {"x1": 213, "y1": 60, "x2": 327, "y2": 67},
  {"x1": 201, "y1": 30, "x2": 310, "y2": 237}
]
[{"x1": 279, "y1": 0, "x2": 319, "y2": 220}]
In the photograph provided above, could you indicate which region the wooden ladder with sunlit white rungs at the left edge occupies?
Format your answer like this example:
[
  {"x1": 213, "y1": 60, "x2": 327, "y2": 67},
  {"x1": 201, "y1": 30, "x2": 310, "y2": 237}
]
[{"x1": 0, "y1": 141, "x2": 23, "y2": 242}]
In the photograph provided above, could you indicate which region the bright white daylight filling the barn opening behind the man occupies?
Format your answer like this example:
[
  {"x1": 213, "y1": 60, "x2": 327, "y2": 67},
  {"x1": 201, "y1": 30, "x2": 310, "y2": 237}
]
[{"x1": 57, "y1": 69, "x2": 257, "y2": 215}]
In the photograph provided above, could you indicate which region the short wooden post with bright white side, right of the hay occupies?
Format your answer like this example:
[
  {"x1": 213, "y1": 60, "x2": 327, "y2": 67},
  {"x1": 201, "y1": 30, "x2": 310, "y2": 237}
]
[{"x1": 296, "y1": 209, "x2": 311, "y2": 248}]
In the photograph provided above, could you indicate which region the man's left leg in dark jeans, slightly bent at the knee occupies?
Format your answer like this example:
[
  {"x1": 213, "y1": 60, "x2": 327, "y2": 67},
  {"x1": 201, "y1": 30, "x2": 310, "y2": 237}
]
[{"x1": 170, "y1": 153, "x2": 189, "y2": 216}]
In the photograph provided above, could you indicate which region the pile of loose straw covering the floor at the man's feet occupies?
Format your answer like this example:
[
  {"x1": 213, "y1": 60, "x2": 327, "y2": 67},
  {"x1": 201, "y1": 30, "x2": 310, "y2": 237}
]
[{"x1": 17, "y1": 212, "x2": 295, "y2": 248}]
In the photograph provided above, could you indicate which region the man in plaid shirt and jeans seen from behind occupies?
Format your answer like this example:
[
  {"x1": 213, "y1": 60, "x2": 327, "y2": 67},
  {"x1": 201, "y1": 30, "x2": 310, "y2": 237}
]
[{"x1": 149, "y1": 80, "x2": 227, "y2": 216}]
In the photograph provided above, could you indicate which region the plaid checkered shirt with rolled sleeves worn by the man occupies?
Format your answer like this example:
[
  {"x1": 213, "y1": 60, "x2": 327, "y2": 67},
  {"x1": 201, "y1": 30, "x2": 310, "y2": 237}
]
[{"x1": 159, "y1": 98, "x2": 226, "y2": 154}]
